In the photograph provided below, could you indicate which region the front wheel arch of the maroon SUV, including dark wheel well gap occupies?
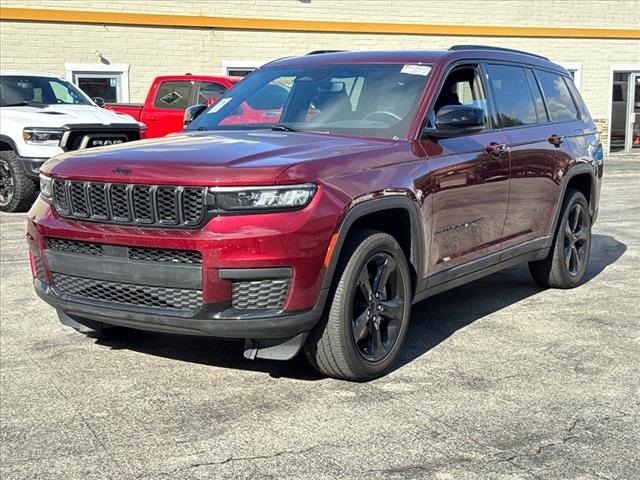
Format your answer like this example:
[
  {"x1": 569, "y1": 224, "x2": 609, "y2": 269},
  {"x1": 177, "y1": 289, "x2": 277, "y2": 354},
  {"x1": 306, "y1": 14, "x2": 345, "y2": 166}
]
[{"x1": 322, "y1": 195, "x2": 424, "y2": 293}]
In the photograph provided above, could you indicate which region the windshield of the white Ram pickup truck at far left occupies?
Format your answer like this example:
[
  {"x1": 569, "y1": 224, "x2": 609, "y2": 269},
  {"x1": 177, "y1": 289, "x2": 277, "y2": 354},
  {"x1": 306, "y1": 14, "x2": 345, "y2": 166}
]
[{"x1": 0, "y1": 75, "x2": 91, "y2": 107}]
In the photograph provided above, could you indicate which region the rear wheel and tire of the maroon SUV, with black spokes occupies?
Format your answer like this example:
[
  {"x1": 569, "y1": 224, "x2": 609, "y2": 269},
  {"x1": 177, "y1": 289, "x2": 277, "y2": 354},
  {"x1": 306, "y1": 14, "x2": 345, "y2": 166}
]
[{"x1": 529, "y1": 189, "x2": 591, "y2": 288}]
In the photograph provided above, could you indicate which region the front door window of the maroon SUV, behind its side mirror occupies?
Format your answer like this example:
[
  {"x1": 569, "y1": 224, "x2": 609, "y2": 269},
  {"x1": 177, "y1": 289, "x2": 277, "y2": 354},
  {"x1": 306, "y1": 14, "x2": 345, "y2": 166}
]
[{"x1": 429, "y1": 66, "x2": 489, "y2": 126}]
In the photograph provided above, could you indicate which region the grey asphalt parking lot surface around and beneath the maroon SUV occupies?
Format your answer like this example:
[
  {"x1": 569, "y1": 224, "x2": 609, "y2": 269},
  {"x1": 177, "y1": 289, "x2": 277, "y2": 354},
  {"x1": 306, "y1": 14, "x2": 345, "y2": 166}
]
[{"x1": 0, "y1": 156, "x2": 640, "y2": 480}]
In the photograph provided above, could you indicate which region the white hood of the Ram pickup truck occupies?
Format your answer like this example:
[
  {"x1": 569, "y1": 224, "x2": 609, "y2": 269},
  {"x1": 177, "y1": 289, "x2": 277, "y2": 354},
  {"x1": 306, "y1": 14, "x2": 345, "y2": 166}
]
[{"x1": 0, "y1": 105, "x2": 137, "y2": 127}]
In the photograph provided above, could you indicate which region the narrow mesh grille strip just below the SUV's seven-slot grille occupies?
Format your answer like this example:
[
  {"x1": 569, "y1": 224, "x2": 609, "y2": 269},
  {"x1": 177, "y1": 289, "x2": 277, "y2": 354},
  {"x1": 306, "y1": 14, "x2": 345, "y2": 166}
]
[{"x1": 47, "y1": 237, "x2": 202, "y2": 264}]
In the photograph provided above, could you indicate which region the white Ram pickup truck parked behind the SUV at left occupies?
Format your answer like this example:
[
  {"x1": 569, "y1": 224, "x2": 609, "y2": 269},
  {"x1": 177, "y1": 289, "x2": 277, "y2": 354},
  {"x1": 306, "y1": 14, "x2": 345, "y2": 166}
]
[{"x1": 0, "y1": 72, "x2": 144, "y2": 212}]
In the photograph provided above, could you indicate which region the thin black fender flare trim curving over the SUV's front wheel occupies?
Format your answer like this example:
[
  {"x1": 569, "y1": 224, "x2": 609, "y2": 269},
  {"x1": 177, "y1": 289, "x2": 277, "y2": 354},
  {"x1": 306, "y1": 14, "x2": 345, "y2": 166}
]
[{"x1": 322, "y1": 194, "x2": 424, "y2": 291}]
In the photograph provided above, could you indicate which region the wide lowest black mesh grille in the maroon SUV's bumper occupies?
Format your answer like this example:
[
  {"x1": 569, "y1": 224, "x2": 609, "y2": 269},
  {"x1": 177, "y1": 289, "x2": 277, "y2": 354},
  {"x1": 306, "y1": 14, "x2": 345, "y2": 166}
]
[{"x1": 53, "y1": 273, "x2": 202, "y2": 311}]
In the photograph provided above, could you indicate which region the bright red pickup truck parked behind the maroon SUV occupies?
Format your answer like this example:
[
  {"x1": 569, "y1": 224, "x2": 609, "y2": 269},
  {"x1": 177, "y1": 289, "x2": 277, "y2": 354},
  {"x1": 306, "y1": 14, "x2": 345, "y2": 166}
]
[{"x1": 105, "y1": 75, "x2": 240, "y2": 138}]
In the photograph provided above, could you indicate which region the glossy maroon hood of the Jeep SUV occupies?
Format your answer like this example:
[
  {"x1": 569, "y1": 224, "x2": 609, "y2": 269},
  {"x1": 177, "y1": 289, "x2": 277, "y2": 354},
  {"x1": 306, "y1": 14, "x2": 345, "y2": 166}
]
[{"x1": 42, "y1": 130, "x2": 394, "y2": 186}]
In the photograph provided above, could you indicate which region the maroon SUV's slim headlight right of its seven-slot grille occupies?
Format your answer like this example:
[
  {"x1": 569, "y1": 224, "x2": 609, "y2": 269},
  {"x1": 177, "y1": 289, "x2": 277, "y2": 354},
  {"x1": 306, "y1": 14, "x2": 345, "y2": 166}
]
[{"x1": 209, "y1": 183, "x2": 316, "y2": 211}]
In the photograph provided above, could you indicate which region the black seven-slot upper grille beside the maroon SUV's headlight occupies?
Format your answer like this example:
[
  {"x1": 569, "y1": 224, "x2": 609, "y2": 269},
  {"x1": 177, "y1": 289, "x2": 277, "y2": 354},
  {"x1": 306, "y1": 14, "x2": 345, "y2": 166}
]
[{"x1": 53, "y1": 180, "x2": 205, "y2": 227}]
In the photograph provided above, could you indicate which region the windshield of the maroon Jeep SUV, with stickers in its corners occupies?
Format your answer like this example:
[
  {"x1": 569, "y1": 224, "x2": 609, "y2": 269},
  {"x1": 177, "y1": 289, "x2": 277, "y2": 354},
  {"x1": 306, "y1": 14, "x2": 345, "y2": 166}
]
[{"x1": 188, "y1": 64, "x2": 431, "y2": 138}]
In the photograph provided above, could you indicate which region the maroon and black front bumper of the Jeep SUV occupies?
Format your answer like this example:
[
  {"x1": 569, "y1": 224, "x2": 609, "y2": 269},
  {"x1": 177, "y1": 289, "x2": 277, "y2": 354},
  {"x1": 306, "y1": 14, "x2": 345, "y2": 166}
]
[{"x1": 27, "y1": 188, "x2": 336, "y2": 340}]
